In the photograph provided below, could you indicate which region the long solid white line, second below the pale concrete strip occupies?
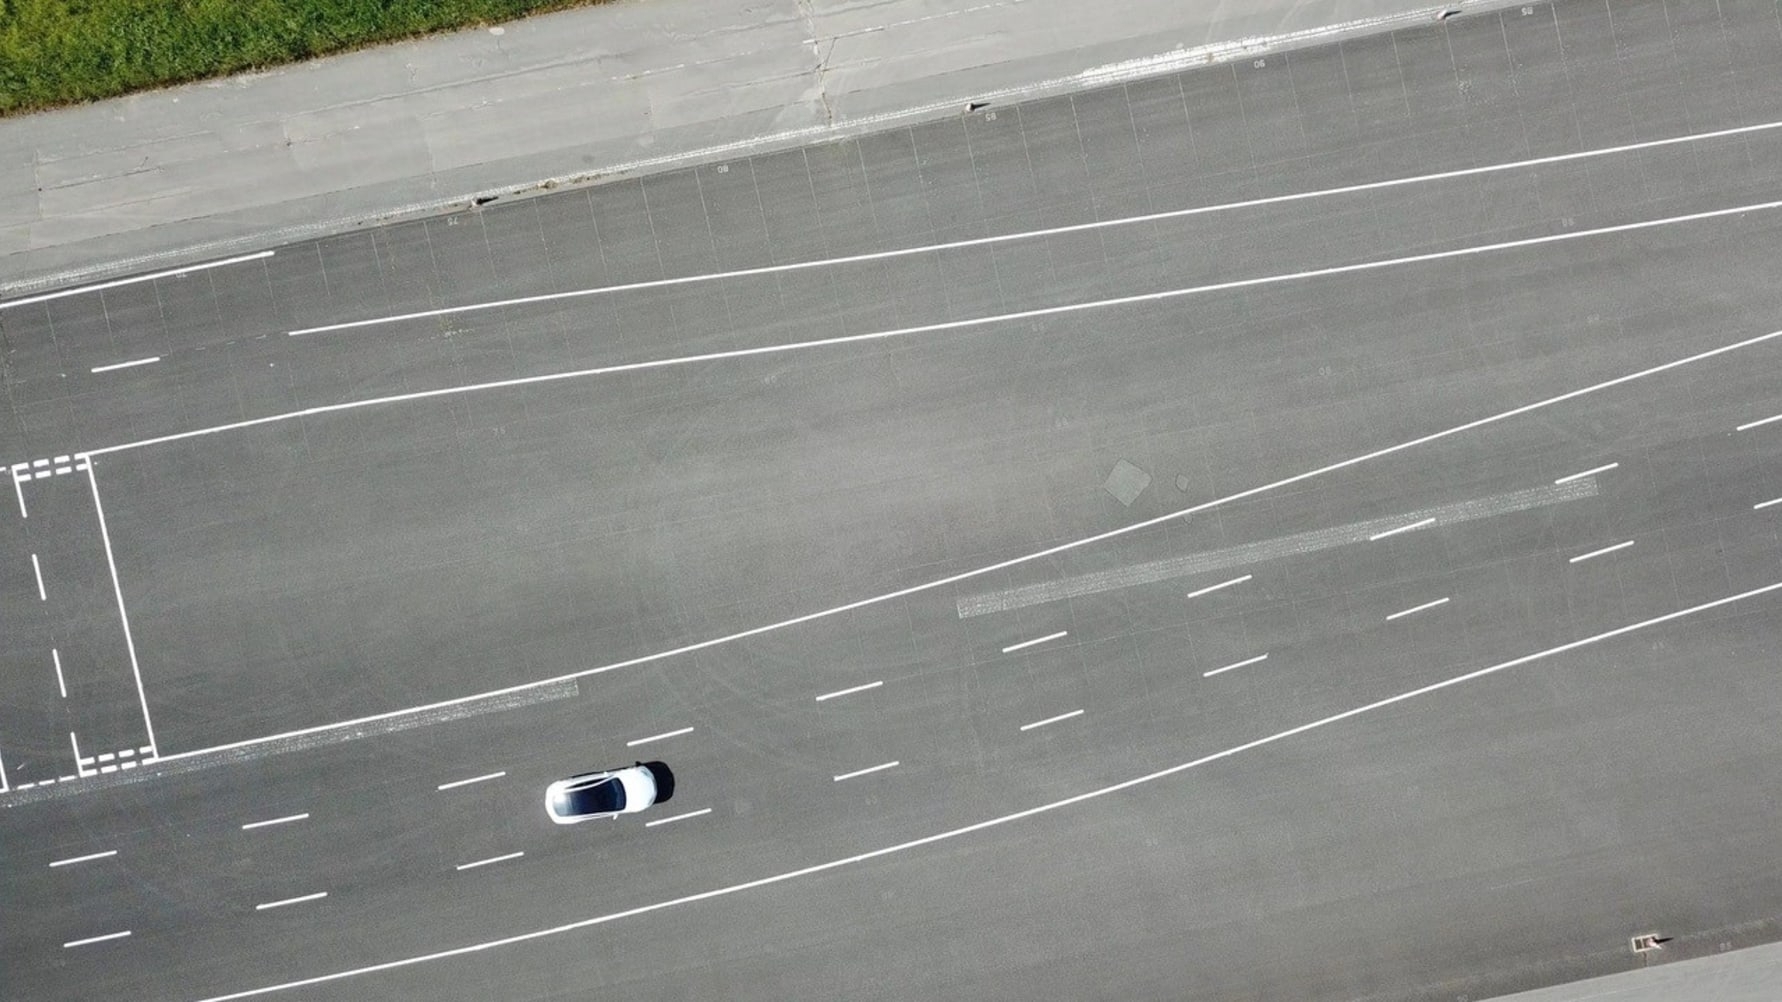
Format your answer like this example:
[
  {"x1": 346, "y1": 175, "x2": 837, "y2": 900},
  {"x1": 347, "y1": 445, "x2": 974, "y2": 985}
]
[{"x1": 97, "y1": 200, "x2": 1782, "y2": 467}]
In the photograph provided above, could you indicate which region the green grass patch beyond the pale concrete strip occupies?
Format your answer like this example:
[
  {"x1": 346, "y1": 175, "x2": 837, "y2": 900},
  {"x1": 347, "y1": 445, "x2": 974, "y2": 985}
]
[{"x1": 0, "y1": 0, "x2": 599, "y2": 116}]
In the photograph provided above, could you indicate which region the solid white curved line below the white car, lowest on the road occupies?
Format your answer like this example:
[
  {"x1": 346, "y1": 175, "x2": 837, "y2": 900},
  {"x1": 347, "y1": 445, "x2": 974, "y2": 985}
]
[{"x1": 198, "y1": 581, "x2": 1782, "y2": 1002}]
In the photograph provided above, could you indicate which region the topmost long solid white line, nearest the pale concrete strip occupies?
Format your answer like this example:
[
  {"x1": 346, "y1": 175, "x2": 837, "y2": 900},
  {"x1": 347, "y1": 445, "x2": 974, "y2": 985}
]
[{"x1": 287, "y1": 121, "x2": 1782, "y2": 337}]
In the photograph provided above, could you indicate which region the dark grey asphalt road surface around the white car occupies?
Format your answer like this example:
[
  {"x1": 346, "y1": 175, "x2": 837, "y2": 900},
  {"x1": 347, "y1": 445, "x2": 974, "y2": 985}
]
[{"x1": 0, "y1": 0, "x2": 1782, "y2": 1000}]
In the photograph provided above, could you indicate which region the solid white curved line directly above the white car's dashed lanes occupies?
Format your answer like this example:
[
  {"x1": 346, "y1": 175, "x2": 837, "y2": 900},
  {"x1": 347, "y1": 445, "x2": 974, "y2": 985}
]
[{"x1": 146, "y1": 330, "x2": 1782, "y2": 761}]
